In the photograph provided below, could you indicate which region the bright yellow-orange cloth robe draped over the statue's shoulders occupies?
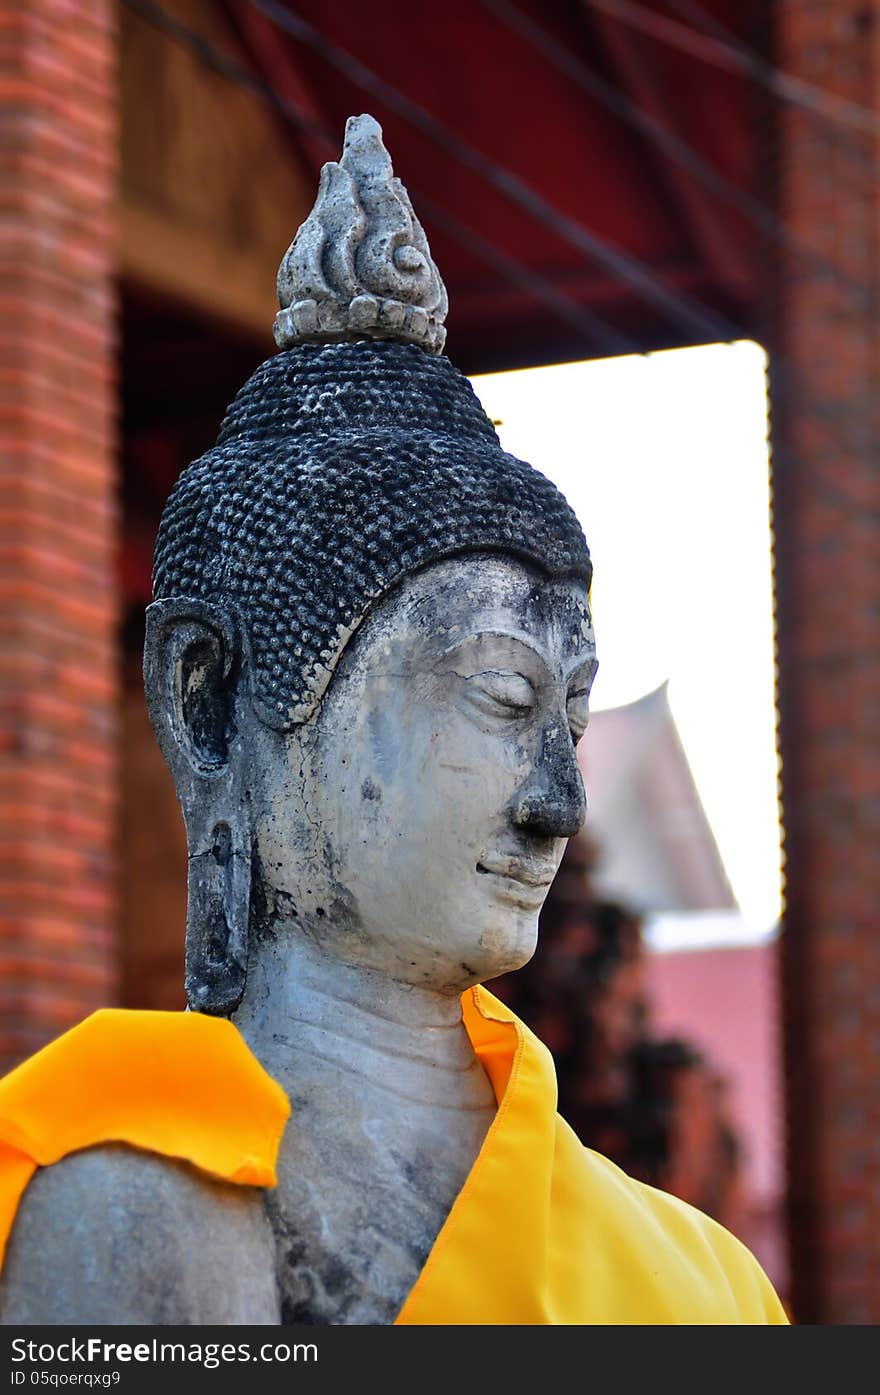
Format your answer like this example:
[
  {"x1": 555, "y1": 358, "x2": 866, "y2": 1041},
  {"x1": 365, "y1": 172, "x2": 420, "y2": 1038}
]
[{"x1": 0, "y1": 989, "x2": 788, "y2": 1325}]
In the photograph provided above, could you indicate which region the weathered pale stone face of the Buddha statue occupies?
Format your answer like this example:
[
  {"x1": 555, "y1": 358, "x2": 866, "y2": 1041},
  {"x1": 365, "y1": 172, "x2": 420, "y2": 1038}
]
[{"x1": 241, "y1": 554, "x2": 595, "y2": 996}]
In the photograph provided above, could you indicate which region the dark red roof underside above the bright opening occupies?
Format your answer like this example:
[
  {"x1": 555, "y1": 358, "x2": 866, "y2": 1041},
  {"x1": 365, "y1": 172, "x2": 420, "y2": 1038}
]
[{"x1": 227, "y1": 0, "x2": 766, "y2": 371}]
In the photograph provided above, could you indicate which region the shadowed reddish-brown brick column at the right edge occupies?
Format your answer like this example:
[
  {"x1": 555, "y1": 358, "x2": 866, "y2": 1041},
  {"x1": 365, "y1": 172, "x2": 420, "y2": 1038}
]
[{"x1": 771, "y1": 0, "x2": 880, "y2": 1324}]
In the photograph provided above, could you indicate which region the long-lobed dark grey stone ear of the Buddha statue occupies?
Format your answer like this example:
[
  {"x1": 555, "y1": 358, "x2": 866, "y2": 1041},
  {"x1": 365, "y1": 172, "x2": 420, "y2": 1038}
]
[{"x1": 144, "y1": 598, "x2": 252, "y2": 1016}]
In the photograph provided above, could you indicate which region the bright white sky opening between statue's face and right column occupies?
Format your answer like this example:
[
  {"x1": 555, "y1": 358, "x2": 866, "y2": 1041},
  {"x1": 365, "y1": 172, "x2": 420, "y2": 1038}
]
[{"x1": 473, "y1": 342, "x2": 780, "y2": 949}]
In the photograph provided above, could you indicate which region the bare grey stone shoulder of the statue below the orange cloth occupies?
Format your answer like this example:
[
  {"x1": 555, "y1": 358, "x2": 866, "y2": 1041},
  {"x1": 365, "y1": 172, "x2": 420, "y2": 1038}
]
[{"x1": 0, "y1": 1144, "x2": 280, "y2": 1325}]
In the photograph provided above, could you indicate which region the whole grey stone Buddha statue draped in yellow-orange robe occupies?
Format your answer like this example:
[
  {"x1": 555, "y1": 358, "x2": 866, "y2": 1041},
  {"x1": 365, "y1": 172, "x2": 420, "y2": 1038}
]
[{"x1": 0, "y1": 116, "x2": 785, "y2": 1325}]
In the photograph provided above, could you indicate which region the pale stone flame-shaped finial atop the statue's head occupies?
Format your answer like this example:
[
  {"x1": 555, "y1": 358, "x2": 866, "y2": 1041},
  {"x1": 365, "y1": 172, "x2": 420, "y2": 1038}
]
[{"x1": 275, "y1": 114, "x2": 449, "y2": 353}]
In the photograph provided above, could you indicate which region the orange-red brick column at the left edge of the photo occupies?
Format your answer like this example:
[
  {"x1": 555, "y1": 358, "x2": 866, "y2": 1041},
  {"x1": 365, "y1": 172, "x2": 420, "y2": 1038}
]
[{"x1": 0, "y1": 0, "x2": 117, "y2": 1069}]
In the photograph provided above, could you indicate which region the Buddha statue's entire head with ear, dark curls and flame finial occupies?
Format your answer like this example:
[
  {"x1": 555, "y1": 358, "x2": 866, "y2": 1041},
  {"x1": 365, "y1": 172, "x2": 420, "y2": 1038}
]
[{"x1": 145, "y1": 116, "x2": 595, "y2": 1013}]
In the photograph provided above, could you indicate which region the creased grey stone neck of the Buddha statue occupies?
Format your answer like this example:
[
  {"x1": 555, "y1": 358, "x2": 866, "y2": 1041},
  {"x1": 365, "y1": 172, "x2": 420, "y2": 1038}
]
[{"x1": 232, "y1": 933, "x2": 494, "y2": 1110}]
